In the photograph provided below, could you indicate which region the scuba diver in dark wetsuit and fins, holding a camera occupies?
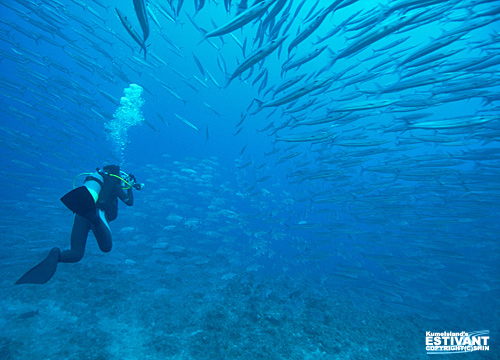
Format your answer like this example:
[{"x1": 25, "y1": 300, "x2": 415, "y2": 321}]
[{"x1": 16, "y1": 165, "x2": 144, "y2": 285}]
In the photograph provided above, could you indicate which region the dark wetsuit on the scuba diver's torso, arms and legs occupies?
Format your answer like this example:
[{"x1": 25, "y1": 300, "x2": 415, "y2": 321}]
[{"x1": 59, "y1": 175, "x2": 134, "y2": 263}]
